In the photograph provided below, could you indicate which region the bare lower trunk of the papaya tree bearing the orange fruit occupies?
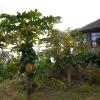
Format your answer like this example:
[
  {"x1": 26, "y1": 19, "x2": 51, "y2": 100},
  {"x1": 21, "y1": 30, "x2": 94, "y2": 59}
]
[{"x1": 24, "y1": 73, "x2": 32, "y2": 100}]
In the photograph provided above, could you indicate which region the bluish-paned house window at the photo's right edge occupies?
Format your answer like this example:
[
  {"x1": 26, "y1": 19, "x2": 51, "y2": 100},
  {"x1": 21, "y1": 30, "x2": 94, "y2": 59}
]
[{"x1": 91, "y1": 32, "x2": 100, "y2": 48}]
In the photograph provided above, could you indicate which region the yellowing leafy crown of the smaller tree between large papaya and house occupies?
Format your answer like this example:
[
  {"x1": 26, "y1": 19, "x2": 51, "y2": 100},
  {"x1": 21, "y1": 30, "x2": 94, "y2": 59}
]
[{"x1": 42, "y1": 30, "x2": 75, "y2": 67}]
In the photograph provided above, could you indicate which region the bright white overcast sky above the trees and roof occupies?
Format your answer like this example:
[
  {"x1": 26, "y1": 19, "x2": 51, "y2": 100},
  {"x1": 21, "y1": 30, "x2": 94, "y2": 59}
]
[{"x1": 0, "y1": 0, "x2": 100, "y2": 30}]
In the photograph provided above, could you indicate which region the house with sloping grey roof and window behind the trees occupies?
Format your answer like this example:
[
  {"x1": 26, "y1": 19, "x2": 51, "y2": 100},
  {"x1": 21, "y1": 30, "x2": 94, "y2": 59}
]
[{"x1": 80, "y1": 19, "x2": 100, "y2": 48}]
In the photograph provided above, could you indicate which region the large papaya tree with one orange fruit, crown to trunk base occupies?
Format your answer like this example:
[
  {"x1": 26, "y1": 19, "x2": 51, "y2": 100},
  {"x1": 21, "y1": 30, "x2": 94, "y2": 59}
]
[{"x1": 0, "y1": 10, "x2": 60, "y2": 100}]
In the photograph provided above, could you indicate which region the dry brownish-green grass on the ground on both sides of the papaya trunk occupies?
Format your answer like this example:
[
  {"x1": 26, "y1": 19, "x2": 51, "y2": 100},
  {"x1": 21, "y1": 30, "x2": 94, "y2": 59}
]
[{"x1": 0, "y1": 79, "x2": 100, "y2": 100}]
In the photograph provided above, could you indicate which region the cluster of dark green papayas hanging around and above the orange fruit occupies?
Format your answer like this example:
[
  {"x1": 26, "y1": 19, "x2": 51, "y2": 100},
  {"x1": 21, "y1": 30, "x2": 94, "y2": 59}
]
[{"x1": 19, "y1": 43, "x2": 37, "y2": 73}]
